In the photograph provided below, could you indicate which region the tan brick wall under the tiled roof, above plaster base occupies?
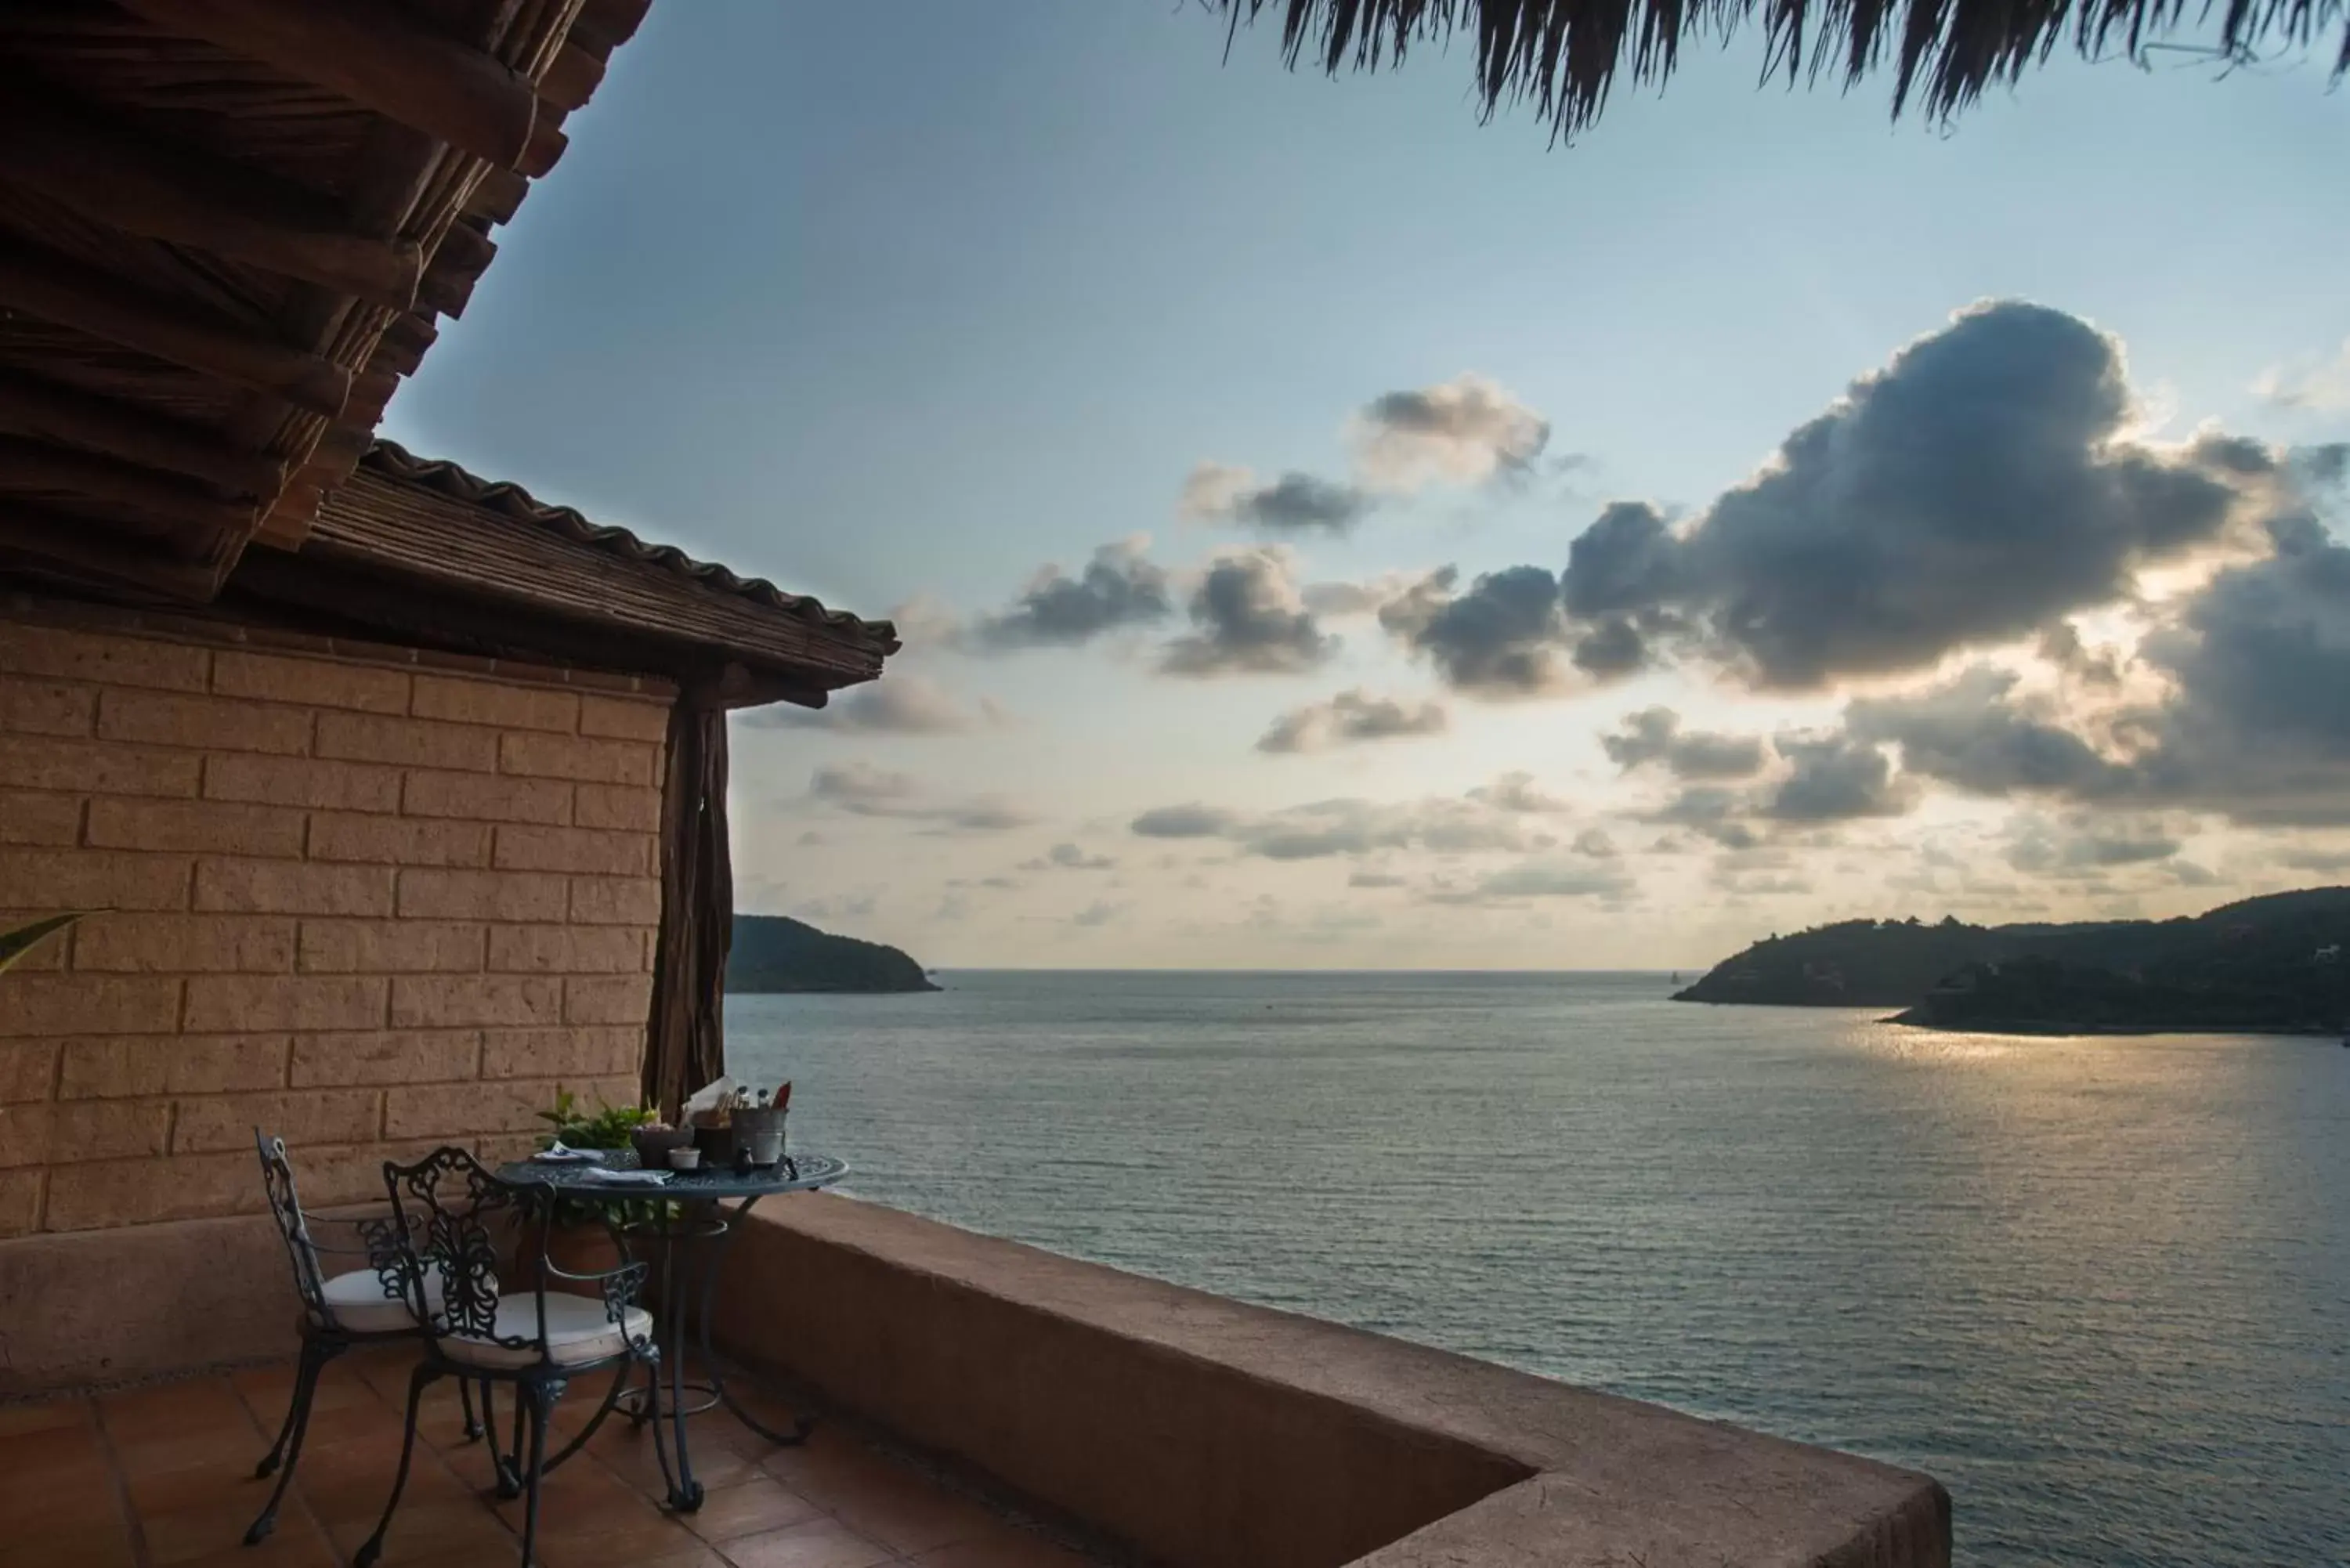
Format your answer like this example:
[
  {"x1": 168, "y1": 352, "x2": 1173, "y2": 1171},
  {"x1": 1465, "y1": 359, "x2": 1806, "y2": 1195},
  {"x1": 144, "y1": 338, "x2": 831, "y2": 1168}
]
[{"x1": 0, "y1": 618, "x2": 667, "y2": 1237}]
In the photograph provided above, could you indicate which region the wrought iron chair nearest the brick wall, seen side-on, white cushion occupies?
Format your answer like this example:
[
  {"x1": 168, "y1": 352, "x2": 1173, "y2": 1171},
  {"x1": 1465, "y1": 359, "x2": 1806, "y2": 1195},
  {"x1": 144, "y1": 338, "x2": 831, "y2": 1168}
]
[{"x1": 244, "y1": 1129, "x2": 482, "y2": 1545}]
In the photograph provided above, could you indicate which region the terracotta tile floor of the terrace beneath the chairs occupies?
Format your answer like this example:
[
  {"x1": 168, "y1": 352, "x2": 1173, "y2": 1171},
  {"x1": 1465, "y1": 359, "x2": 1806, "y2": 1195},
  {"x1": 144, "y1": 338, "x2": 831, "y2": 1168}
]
[{"x1": 0, "y1": 1349, "x2": 1093, "y2": 1568}]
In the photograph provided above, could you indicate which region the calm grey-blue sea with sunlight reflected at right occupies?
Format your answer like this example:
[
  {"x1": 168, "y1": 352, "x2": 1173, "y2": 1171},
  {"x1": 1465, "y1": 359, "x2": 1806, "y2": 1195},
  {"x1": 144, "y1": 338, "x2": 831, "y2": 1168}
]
[{"x1": 728, "y1": 971, "x2": 2350, "y2": 1568}]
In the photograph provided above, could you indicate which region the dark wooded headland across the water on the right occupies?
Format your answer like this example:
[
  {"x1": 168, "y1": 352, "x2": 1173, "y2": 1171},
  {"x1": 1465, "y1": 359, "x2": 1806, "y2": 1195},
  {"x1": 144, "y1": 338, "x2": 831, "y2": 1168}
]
[{"x1": 1673, "y1": 887, "x2": 2350, "y2": 1035}]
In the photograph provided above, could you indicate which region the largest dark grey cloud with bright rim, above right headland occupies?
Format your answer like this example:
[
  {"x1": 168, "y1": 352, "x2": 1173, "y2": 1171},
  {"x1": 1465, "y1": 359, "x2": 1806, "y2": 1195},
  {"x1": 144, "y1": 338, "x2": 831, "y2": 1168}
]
[{"x1": 1384, "y1": 301, "x2": 2305, "y2": 695}]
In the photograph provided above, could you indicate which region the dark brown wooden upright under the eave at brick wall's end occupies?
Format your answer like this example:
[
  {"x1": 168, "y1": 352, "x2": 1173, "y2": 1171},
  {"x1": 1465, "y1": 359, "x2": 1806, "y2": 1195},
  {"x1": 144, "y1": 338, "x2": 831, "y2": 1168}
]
[{"x1": 644, "y1": 693, "x2": 733, "y2": 1122}]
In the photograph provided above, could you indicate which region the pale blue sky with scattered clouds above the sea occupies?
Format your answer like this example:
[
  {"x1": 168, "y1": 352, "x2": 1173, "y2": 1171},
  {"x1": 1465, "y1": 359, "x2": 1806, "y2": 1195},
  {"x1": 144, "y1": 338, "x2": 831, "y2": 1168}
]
[{"x1": 383, "y1": 0, "x2": 2350, "y2": 969}]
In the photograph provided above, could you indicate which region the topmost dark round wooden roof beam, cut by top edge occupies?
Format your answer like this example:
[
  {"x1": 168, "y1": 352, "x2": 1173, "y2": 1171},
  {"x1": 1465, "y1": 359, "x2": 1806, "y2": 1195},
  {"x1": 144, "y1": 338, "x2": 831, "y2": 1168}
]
[{"x1": 122, "y1": 0, "x2": 540, "y2": 169}]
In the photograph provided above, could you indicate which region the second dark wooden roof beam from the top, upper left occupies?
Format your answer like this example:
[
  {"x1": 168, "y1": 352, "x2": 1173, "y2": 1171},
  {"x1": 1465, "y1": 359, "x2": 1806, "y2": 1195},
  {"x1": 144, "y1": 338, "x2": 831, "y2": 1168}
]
[{"x1": 0, "y1": 80, "x2": 423, "y2": 310}]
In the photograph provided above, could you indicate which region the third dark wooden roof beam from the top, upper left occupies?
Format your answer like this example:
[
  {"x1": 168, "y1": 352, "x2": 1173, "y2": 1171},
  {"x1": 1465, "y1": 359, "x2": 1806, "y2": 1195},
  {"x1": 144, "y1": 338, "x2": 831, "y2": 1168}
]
[{"x1": 0, "y1": 244, "x2": 350, "y2": 418}]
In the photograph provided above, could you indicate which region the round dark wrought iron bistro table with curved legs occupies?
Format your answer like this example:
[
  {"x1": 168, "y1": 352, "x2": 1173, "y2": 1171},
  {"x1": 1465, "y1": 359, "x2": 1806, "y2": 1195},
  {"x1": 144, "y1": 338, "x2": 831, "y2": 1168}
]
[{"x1": 491, "y1": 1150, "x2": 848, "y2": 1514}]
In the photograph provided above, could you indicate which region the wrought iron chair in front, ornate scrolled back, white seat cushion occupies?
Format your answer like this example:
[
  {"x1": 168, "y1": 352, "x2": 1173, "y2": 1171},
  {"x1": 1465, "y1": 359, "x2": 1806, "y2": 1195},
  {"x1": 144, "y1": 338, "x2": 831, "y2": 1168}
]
[{"x1": 350, "y1": 1147, "x2": 677, "y2": 1568}]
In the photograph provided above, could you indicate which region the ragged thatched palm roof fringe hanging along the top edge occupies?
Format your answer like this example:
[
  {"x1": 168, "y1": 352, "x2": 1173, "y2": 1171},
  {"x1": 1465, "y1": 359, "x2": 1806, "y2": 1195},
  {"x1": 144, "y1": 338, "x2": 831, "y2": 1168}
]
[{"x1": 1206, "y1": 0, "x2": 2350, "y2": 136}]
